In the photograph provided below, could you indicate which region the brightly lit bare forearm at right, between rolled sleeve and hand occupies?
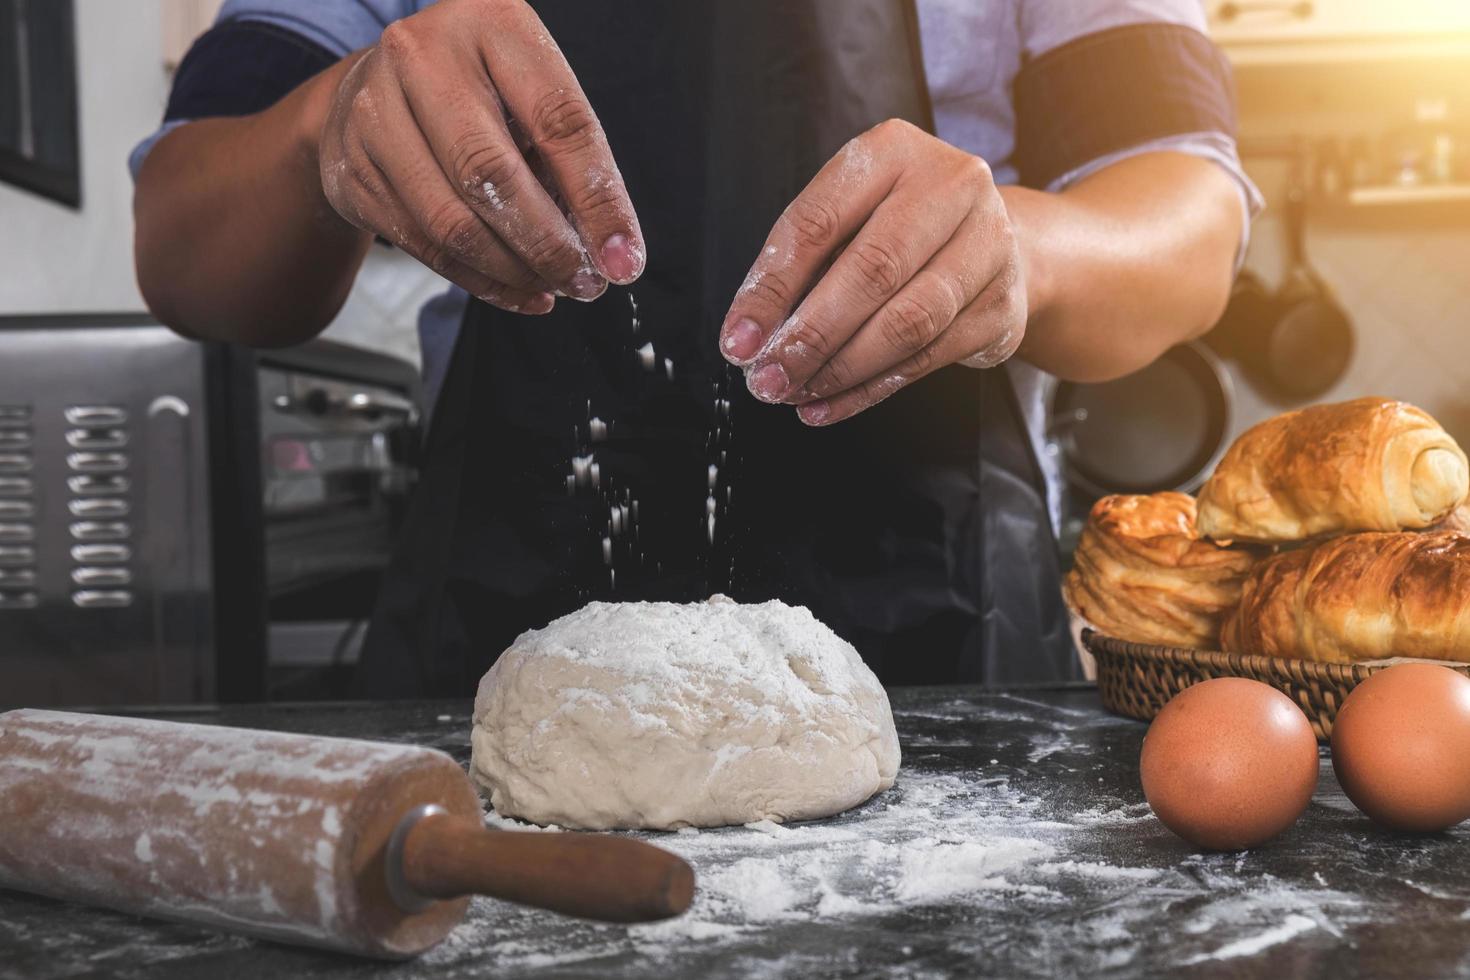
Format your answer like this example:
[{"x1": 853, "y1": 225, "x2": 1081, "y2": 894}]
[{"x1": 1001, "y1": 153, "x2": 1241, "y2": 382}]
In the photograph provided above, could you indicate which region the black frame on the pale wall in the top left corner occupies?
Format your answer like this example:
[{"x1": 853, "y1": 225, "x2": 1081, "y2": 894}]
[{"x1": 0, "y1": 0, "x2": 82, "y2": 207}]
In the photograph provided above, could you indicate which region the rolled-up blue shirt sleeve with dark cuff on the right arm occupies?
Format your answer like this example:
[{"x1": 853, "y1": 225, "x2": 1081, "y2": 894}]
[{"x1": 1013, "y1": 0, "x2": 1264, "y2": 266}]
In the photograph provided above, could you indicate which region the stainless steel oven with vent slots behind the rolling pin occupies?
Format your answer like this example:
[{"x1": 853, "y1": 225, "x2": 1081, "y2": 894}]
[{"x1": 0, "y1": 316, "x2": 416, "y2": 705}]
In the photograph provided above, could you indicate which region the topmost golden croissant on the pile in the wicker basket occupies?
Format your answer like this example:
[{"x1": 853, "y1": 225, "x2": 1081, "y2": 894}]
[{"x1": 1200, "y1": 398, "x2": 1470, "y2": 542}]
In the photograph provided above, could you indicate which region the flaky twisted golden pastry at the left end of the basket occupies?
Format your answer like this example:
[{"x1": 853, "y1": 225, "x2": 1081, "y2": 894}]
[{"x1": 1063, "y1": 492, "x2": 1258, "y2": 648}]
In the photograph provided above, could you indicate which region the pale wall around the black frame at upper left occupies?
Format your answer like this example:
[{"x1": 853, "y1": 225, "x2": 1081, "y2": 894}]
[{"x1": 0, "y1": 0, "x2": 168, "y2": 314}]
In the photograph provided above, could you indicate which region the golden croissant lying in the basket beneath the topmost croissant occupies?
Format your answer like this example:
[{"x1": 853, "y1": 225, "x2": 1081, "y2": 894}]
[{"x1": 1220, "y1": 530, "x2": 1470, "y2": 663}]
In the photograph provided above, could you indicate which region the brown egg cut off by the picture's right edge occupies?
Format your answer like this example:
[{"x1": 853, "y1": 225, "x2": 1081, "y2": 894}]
[{"x1": 1332, "y1": 664, "x2": 1470, "y2": 833}]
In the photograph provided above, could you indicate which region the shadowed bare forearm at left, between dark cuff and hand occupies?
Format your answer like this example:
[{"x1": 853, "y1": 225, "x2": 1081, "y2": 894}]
[{"x1": 134, "y1": 52, "x2": 372, "y2": 347}]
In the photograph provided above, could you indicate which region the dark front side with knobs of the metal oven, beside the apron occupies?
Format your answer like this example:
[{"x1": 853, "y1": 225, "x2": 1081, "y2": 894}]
[{"x1": 256, "y1": 342, "x2": 419, "y2": 698}]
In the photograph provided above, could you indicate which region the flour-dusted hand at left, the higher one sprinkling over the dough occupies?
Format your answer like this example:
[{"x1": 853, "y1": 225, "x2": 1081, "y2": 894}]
[{"x1": 319, "y1": 0, "x2": 644, "y2": 313}]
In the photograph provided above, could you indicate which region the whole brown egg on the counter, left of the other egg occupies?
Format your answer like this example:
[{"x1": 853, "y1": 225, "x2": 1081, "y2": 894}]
[{"x1": 1139, "y1": 677, "x2": 1317, "y2": 851}]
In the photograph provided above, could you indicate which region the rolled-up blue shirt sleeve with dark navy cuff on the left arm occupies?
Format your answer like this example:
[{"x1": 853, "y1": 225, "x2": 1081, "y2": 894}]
[{"x1": 128, "y1": 0, "x2": 419, "y2": 178}]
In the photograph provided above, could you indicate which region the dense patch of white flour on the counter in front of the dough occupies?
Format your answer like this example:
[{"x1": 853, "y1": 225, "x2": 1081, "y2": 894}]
[{"x1": 420, "y1": 771, "x2": 1193, "y2": 974}]
